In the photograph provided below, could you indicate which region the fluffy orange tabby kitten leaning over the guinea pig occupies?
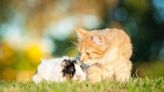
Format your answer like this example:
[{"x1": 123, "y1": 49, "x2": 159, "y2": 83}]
[{"x1": 76, "y1": 28, "x2": 132, "y2": 82}]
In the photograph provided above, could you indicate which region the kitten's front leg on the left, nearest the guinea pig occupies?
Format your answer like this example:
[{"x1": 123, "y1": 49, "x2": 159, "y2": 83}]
[{"x1": 87, "y1": 65, "x2": 102, "y2": 82}]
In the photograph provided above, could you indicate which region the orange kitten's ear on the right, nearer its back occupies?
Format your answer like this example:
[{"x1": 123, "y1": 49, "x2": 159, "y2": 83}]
[{"x1": 91, "y1": 35, "x2": 104, "y2": 45}]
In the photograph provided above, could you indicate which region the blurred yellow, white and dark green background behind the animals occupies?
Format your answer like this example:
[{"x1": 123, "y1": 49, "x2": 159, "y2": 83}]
[{"x1": 0, "y1": 0, "x2": 164, "y2": 81}]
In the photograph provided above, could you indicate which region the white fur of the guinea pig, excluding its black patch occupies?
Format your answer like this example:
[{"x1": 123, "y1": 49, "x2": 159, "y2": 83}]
[{"x1": 32, "y1": 56, "x2": 86, "y2": 83}]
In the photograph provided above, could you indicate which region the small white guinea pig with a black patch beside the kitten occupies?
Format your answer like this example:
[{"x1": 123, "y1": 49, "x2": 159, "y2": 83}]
[{"x1": 32, "y1": 56, "x2": 86, "y2": 83}]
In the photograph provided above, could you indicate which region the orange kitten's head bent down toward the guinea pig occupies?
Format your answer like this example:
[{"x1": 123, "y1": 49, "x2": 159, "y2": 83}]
[{"x1": 75, "y1": 28, "x2": 108, "y2": 63}]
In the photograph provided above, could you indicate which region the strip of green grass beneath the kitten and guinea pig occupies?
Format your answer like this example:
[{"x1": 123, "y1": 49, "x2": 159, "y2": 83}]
[{"x1": 0, "y1": 78, "x2": 164, "y2": 92}]
